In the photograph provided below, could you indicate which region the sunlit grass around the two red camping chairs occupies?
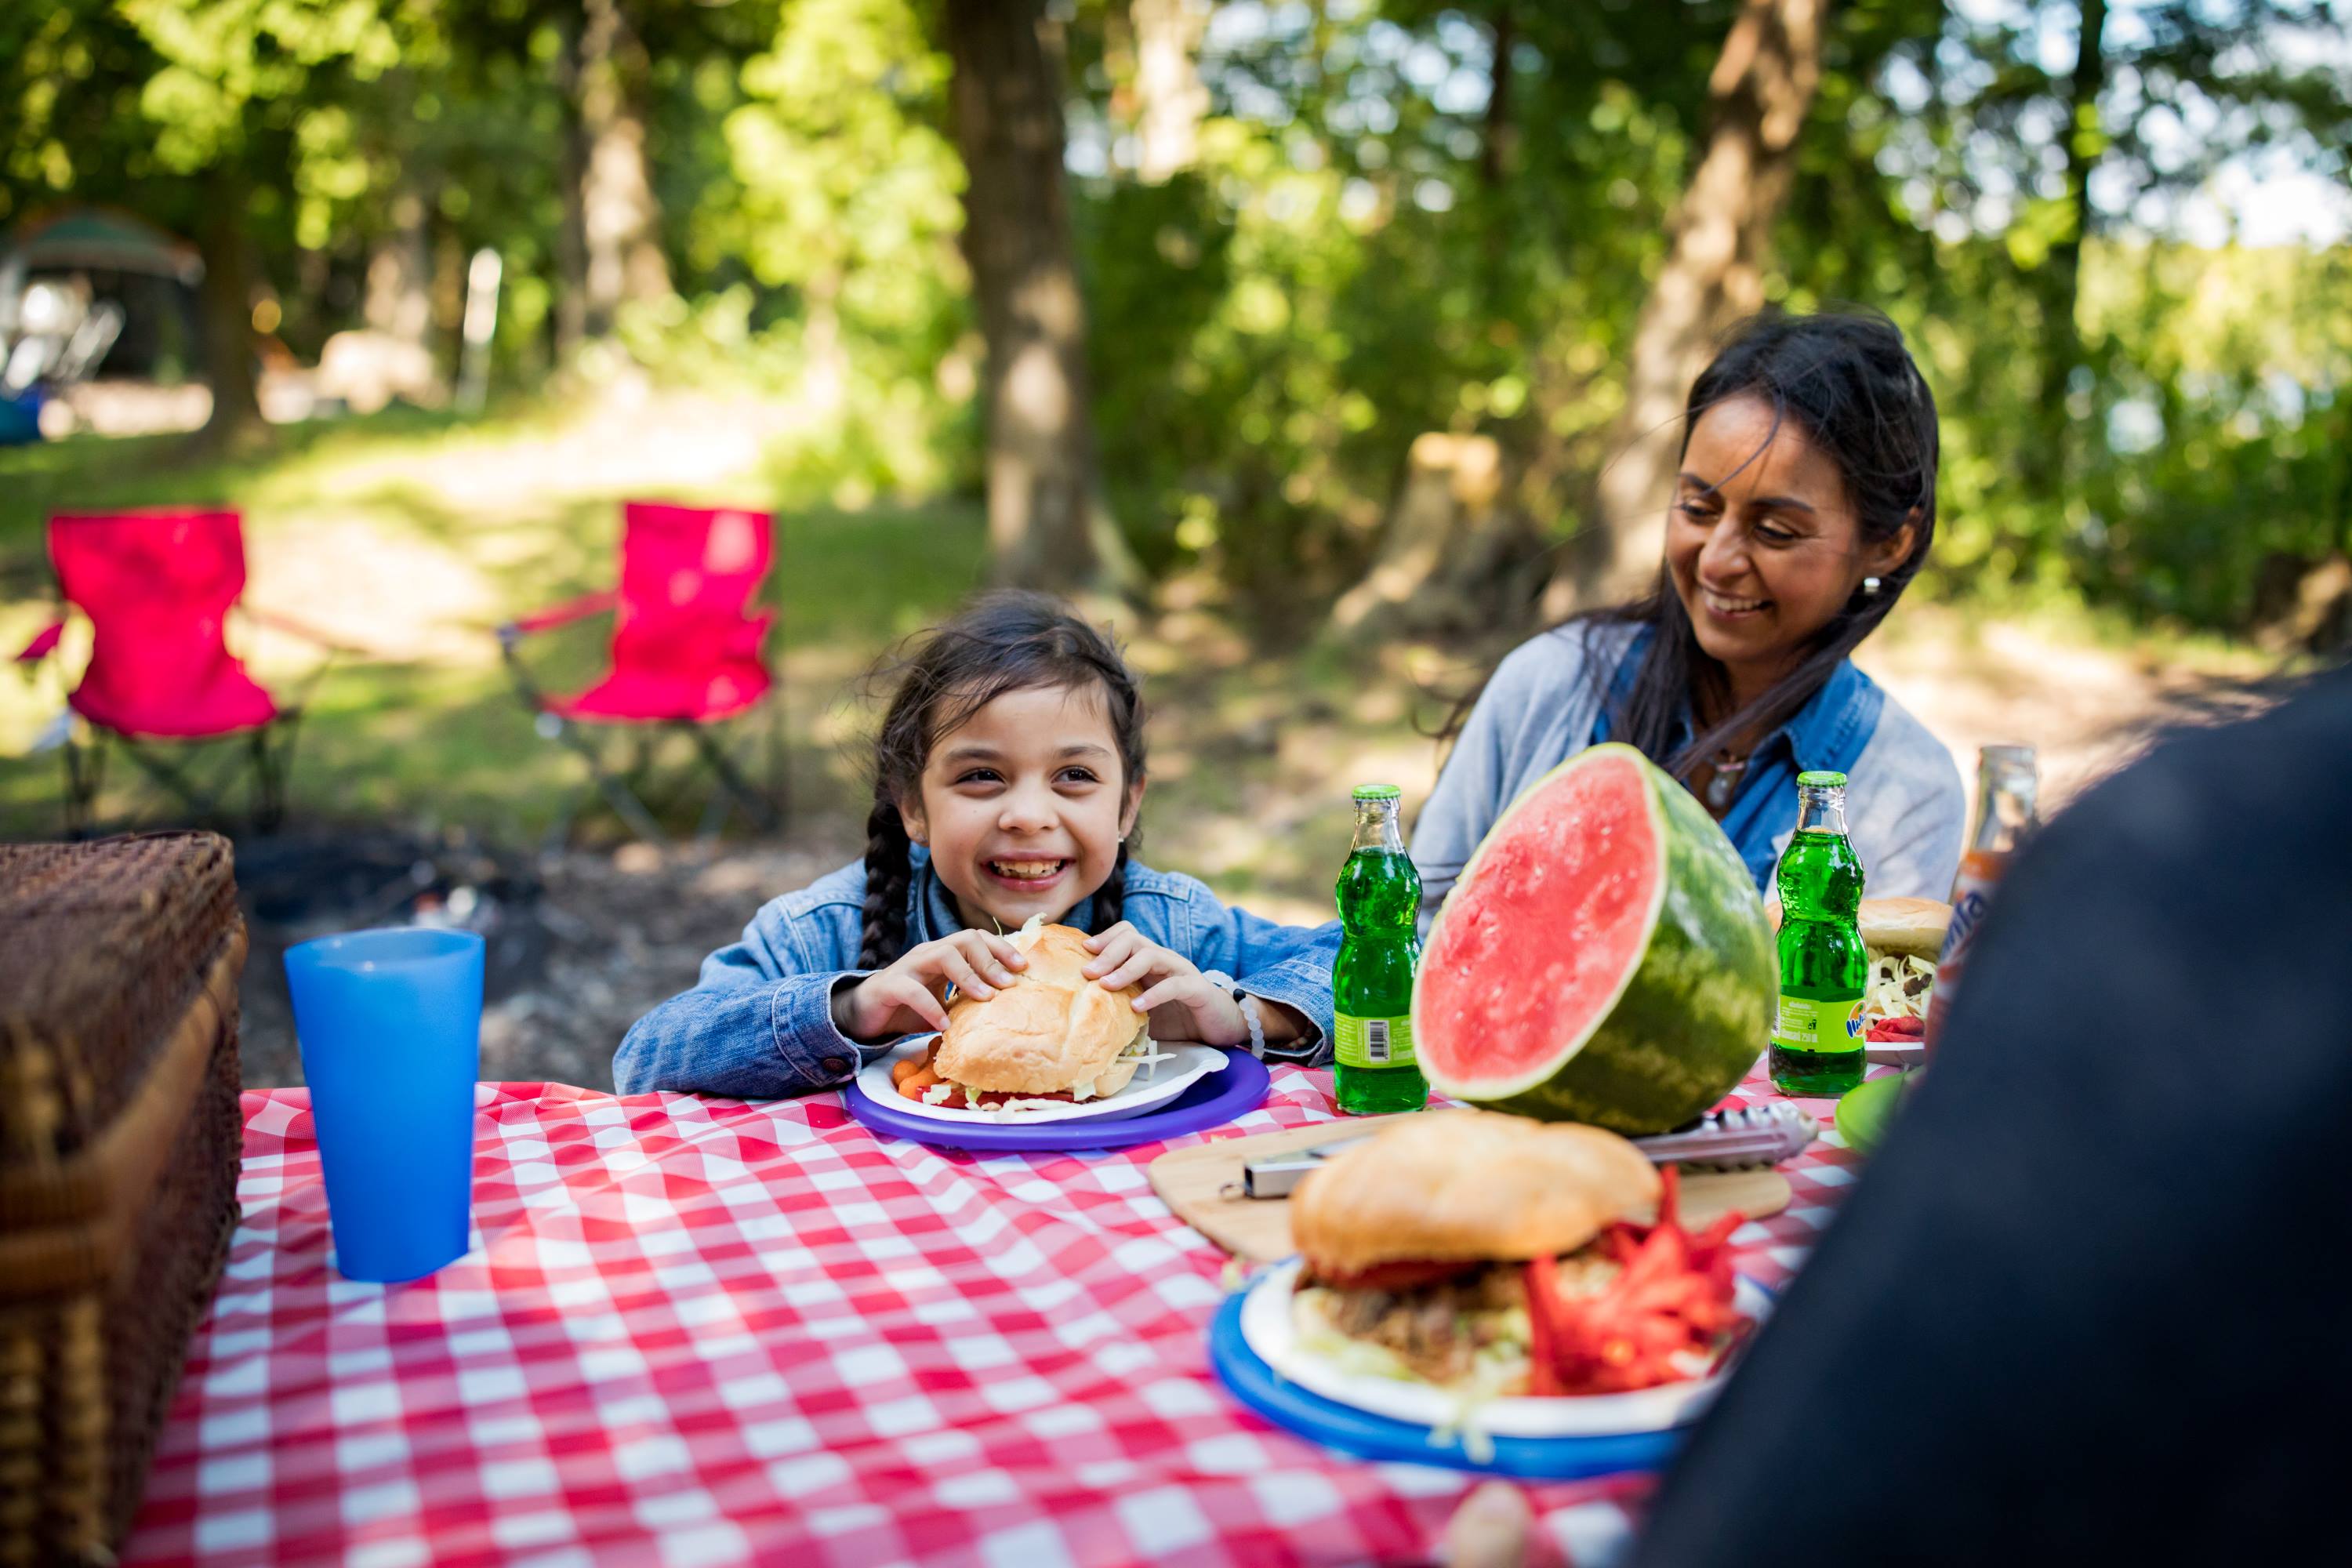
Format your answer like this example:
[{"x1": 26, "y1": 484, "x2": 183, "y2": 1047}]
[{"x1": 0, "y1": 412, "x2": 988, "y2": 841}]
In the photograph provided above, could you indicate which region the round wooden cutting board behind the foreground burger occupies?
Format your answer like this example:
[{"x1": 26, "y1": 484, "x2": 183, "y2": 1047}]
[{"x1": 1150, "y1": 1116, "x2": 1788, "y2": 1262}]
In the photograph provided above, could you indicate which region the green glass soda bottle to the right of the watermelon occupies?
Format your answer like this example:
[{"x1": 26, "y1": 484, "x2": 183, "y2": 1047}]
[{"x1": 1771, "y1": 774, "x2": 1870, "y2": 1098}]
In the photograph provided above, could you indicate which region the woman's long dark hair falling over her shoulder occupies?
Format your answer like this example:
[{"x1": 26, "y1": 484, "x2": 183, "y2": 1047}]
[{"x1": 1449, "y1": 310, "x2": 1940, "y2": 781}]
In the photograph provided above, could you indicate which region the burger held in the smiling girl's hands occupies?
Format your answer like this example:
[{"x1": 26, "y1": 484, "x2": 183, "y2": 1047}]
[{"x1": 891, "y1": 919, "x2": 1160, "y2": 1109}]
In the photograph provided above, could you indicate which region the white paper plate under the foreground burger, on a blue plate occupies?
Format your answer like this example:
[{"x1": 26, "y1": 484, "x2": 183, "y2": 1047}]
[{"x1": 1242, "y1": 1258, "x2": 1771, "y2": 1436}]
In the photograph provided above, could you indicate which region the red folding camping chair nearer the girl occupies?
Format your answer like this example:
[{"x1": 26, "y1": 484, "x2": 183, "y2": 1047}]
[{"x1": 499, "y1": 501, "x2": 783, "y2": 844}]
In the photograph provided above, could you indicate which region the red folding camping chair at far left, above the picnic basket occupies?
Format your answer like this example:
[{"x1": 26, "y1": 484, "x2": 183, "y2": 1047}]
[{"x1": 16, "y1": 508, "x2": 341, "y2": 834}]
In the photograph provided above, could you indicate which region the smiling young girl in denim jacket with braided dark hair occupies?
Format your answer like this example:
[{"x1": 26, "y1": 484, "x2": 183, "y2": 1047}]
[{"x1": 612, "y1": 593, "x2": 1338, "y2": 1100}]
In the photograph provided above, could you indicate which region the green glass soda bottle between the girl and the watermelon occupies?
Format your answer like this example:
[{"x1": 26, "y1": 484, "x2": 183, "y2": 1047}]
[{"x1": 1331, "y1": 785, "x2": 1430, "y2": 1116}]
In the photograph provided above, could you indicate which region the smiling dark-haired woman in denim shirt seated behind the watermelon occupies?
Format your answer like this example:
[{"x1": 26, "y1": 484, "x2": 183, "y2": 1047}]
[{"x1": 1414, "y1": 313, "x2": 1966, "y2": 912}]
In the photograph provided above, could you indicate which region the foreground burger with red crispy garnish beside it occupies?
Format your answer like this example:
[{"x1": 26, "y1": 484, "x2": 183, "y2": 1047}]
[{"x1": 1291, "y1": 1109, "x2": 1745, "y2": 1399}]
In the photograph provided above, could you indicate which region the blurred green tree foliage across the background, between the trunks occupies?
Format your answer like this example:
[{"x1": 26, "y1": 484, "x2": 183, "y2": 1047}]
[{"x1": 0, "y1": 0, "x2": 2352, "y2": 628}]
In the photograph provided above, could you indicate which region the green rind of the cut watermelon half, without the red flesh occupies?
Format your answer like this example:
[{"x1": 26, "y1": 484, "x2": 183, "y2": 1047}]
[{"x1": 1414, "y1": 743, "x2": 1778, "y2": 1135}]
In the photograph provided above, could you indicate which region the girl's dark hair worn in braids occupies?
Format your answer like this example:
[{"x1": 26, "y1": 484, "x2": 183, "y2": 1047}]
[{"x1": 858, "y1": 590, "x2": 1143, "y2": 968}]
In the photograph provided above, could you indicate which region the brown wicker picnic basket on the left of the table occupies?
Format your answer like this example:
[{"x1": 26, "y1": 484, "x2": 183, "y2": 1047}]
[{"x1": 0, "y1": 832, "x2": 245, "y2": 1568}]
